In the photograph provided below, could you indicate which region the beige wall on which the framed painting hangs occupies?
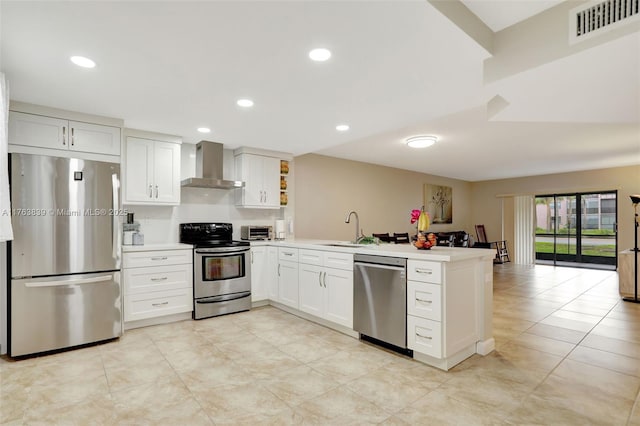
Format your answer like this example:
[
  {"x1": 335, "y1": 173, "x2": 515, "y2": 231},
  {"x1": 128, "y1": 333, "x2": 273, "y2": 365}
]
[{"x1": 295, "y1": 154, "x2": 473, "y2": 240}]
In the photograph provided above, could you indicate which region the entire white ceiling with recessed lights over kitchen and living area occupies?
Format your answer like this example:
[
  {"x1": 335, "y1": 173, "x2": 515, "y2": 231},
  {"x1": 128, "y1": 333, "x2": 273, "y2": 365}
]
[{"x1": 0, "y1": 0, "x2": 640, "y2": 181}]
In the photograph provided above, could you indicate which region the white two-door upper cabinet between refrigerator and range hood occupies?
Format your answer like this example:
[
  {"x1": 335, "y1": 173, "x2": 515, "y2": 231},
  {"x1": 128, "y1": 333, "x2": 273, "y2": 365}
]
[{"x1": 123, "y1": 136, "x2": 180, "y2": 205}]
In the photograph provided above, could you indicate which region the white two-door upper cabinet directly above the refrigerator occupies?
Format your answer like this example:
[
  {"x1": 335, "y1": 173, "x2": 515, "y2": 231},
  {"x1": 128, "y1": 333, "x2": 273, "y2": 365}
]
[{"x1": 9, "y1": 111, "x2": 120, "y2": 156}]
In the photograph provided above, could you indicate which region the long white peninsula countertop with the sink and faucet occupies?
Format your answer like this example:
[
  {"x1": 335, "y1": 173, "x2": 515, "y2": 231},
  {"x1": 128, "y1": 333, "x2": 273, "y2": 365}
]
[{"x1": 251, "y1": 239, "x2": 496, "y2": 262}]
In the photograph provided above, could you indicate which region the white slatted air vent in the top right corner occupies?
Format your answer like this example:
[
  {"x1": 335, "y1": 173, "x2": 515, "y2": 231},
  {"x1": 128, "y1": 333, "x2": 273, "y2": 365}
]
[{"x1": 569, "y1": 0, "x2": 640, "y2": 44}]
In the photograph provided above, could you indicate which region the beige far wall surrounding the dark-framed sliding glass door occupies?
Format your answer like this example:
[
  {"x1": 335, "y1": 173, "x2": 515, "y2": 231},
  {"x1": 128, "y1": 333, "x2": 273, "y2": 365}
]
[{"x1": 471, "y1": 166, "x2": 640, "y2": 260}]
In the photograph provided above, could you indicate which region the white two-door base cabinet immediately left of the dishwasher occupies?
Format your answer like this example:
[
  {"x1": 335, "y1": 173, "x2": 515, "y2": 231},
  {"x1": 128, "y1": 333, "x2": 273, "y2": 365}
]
[{"x1": 299, "y1": 249, "x2": 353, "y2": 328}]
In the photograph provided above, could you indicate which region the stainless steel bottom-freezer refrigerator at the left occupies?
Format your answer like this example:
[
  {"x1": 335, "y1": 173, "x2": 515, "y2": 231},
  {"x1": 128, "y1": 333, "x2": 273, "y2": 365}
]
[{"x1": 7, "y1": 154, "x2": 122, "y2": 357}]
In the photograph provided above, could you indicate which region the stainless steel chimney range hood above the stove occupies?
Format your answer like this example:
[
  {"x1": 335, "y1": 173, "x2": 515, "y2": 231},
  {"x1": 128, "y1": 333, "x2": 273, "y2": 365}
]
[{"x1": 181, "y1": 141, "x2": 244, "y2": 189}]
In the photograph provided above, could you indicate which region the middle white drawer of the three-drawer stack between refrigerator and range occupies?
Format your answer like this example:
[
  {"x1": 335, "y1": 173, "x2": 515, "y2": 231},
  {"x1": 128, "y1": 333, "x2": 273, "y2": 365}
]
[{"x1": 123, "y1": 265, "x2": 193, "y2": 294}]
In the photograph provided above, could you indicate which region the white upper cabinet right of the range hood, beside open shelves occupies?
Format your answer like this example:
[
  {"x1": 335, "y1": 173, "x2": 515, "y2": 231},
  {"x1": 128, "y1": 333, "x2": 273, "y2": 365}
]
[{"x1": 234, "y1": 148, "x2": 291, "y2": 209}]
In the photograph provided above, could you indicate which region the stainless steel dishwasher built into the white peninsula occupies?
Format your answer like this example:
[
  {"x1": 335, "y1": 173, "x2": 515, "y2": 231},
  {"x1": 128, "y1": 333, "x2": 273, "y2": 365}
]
[{"x1": 353, "y1": 254, "x2": 410, "y2": 353}]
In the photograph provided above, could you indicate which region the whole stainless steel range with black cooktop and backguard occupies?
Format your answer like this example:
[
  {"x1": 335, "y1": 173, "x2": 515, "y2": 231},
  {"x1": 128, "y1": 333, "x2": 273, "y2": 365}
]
[{"x1": 180, "y1": 223, "x2": 251, "y2": 319}]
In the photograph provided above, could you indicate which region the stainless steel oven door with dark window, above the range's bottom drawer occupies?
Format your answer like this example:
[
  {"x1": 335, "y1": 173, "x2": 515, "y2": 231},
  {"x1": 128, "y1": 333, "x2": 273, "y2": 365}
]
[{"x1": 193, "y1": 247, "x2": 251, "y2": 299}]
